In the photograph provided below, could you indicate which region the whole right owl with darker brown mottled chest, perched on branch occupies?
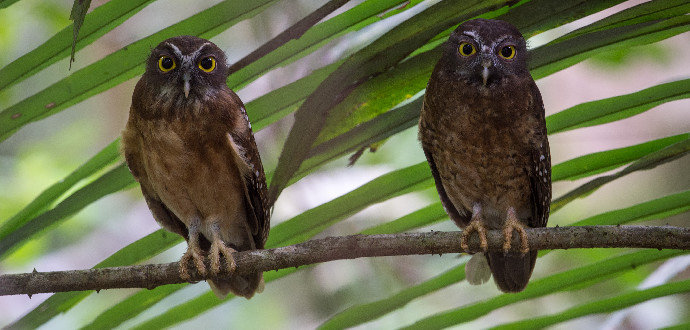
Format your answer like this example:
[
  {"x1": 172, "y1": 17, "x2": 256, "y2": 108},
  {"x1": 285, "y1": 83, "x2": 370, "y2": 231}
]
[{"x1": 419, "y1": 19, "x2": 551, "y2": 292}]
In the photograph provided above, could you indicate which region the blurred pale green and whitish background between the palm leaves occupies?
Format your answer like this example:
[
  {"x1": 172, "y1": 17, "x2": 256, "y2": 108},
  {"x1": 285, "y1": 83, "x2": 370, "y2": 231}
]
[{"x1": 0, "y1": 0, "x2": 690, "y2": 329}]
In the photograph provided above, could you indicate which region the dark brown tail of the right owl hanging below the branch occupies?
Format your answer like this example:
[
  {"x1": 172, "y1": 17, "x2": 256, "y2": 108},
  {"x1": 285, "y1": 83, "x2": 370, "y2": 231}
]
[{"x1": 486, "y1": 251, "x2": 537, "y2": 292}]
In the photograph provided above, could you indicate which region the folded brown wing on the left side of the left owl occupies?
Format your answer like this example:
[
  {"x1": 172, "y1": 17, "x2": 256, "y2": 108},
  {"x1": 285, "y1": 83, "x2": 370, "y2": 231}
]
[{"x1": 122, "y1": 123, "x2": 189, "y2": 240}]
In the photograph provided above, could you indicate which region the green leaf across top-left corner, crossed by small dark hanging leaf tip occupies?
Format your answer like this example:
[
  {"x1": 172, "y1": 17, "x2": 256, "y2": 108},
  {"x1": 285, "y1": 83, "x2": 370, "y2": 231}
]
[{"x1": 0, "y1": 0, "x2": 153, "y2": 90}]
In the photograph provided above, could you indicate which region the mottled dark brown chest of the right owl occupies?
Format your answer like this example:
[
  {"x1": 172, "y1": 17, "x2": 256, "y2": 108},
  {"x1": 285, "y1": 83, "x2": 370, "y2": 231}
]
[{"x1": 421, "y1": 87, "x2": 539, "y2": 214}]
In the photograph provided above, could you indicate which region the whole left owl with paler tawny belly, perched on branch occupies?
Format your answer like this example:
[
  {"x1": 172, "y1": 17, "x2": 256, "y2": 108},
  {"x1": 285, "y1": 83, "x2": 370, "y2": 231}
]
[{"x1": 122, "y1": 36, "x2": 270, "y2": 298}]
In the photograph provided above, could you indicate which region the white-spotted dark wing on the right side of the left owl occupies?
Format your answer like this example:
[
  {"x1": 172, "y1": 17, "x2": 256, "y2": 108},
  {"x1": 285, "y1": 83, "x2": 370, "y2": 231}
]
[{"x1": 228, "y1": 92, "x2": 271, "y2": 248}]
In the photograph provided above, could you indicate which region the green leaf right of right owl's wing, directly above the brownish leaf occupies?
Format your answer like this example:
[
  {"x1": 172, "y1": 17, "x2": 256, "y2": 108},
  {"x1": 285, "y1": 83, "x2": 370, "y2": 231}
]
[{"x1": 551, "y1": 134, "x2": 690, "y2": 181}]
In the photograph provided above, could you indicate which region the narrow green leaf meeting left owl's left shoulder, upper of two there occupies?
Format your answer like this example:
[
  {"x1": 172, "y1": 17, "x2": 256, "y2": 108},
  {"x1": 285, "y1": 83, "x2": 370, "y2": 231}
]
[{"x1": 0, "y1": 140, "x2": 120, "y2": 241}]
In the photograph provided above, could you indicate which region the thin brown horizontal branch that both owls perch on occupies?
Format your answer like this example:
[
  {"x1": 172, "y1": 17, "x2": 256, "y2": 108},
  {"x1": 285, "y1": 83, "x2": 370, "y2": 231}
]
[{"x1": 0, "y1": 226, "x2": 690, "y2": 295}]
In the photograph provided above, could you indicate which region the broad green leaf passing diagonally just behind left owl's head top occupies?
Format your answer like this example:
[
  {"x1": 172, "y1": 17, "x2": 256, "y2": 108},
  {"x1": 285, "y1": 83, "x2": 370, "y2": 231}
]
[{"x1": 0, "y1": 0, "x2": 277, "y2": 141}]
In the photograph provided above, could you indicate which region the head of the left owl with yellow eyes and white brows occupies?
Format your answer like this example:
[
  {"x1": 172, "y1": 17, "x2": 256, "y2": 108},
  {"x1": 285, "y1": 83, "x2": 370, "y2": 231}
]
[{"x1": 142, "y1": 36, "x2": 228, "y2": 103}]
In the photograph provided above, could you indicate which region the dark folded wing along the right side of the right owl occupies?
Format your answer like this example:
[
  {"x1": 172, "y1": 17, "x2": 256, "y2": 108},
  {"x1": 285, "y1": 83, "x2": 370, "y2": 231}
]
[{"x1": 526, "y1": 84, "x2": 551, "y2": 227}]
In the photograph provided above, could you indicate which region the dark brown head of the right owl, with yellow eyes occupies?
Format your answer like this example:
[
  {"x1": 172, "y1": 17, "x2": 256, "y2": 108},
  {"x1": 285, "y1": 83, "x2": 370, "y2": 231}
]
[{"x1": 442, "y1": 19, "x2": 529, "y2": 88}]
